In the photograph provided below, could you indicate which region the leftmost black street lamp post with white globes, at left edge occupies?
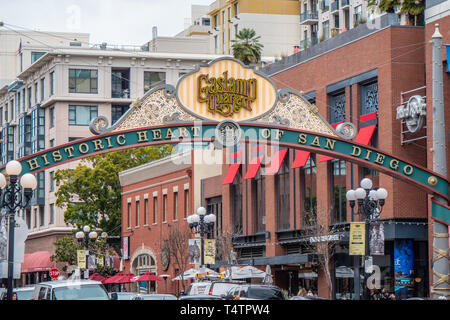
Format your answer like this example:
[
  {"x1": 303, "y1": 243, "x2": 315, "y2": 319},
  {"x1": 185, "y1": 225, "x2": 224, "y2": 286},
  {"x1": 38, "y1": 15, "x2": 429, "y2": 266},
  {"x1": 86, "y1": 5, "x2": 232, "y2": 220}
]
[{"x1": 0, "y1": 160, "x2": 37, "y2": 300}]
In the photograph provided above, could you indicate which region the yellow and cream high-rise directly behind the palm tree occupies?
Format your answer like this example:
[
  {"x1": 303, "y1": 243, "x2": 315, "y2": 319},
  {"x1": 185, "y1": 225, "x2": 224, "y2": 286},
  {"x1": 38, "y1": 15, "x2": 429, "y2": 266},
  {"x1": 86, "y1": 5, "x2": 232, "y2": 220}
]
[{"x1": 208, "y1": 0, "x2": 300, "y2": 61}]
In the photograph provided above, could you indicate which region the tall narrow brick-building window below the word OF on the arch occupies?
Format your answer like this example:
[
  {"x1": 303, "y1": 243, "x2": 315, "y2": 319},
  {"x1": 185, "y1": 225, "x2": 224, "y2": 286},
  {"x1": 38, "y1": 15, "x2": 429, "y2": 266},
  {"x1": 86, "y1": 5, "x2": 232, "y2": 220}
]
[{"x1": 275, "y1": 155, "x2": 290, "y2": 230}]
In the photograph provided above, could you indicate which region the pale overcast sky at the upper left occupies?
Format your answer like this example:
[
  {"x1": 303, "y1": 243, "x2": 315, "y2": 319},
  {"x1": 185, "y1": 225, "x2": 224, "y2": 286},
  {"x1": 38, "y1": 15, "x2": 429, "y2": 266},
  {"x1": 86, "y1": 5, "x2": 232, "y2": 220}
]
[{"x1": 0, "y1": 0, "x2": 214, "y2": 45}]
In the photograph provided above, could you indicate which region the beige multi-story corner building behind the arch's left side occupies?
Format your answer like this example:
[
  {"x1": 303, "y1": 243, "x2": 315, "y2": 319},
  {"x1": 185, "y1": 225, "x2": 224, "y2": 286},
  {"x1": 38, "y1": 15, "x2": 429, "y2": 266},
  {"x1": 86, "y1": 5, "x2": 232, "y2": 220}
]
[{"x1": 0, "y1": 35, "x2": 221, "y2": 282}]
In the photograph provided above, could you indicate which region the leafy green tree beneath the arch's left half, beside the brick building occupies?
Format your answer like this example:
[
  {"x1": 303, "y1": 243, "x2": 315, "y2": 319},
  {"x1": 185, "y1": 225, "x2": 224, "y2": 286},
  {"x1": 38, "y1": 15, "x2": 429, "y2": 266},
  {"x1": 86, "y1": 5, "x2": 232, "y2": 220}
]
[{"x1": 55, "y1": 145, "x2": 172, "y2": 236}]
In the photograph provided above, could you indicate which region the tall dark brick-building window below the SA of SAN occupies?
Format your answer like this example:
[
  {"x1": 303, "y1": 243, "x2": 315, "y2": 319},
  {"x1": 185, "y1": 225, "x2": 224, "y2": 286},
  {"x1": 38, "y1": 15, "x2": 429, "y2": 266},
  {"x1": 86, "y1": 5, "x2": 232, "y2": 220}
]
[{"x1": 300, "y1": 154, "x2": 317, "y2": 225}]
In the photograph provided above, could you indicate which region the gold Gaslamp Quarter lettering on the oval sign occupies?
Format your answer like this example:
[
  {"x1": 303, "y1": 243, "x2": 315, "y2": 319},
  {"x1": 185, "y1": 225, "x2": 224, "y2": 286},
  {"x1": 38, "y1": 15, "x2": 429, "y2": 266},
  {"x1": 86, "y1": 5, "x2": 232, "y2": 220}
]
[{"x1": 197, "y1": 71, "x2": 258, "y2": 117}]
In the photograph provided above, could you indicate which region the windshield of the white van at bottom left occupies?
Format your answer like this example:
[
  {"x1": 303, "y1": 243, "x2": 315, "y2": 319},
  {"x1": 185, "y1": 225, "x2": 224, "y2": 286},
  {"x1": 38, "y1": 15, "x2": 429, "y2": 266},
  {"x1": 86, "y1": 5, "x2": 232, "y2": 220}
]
[{"x1": 53, "y1": 284, "x2": 109, "y2": 300}]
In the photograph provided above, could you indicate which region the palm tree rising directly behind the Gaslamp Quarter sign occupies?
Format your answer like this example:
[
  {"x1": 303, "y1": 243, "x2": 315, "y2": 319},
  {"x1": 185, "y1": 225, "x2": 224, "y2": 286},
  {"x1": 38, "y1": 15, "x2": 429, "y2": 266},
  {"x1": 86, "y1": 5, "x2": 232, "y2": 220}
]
[{"x1": 231, "y1": 29, "x2": 264, "y2": 65}]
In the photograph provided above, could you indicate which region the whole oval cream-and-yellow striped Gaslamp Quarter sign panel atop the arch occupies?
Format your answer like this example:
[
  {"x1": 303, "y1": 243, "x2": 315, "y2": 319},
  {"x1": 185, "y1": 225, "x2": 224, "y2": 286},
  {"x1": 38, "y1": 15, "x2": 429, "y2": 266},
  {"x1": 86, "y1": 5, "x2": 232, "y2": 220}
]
[{"x1": 176, "y1": 57, "x2": 278, "y2": 122}]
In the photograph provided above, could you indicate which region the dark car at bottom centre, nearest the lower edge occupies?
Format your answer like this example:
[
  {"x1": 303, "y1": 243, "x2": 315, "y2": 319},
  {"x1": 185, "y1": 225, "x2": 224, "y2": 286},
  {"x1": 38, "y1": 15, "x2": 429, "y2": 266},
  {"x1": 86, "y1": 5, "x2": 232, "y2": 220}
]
[{"x1": 224, "y1": 284, "x2": 286, "y2": 300}]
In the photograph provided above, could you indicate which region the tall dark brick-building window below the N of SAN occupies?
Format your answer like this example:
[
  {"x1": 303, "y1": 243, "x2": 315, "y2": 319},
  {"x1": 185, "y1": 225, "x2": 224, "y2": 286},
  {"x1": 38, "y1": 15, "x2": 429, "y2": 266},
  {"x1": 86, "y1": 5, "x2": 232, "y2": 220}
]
[{"x1": 330, "y1": 159, "x2": 347, "y2": 223}]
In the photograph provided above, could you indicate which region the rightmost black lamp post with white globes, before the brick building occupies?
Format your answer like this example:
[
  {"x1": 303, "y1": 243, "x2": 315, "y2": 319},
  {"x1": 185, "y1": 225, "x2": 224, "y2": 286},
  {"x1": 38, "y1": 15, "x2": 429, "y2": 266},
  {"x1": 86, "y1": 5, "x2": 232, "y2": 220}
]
[{"x1": 346, "y1": 178, "x2": 388, "y2": 300}]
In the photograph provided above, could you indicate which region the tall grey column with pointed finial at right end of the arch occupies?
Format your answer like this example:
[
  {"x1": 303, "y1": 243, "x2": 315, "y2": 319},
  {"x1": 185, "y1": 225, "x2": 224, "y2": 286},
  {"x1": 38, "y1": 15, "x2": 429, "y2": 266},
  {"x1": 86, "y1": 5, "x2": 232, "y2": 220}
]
[{"x1": 432, "y1": 24, "x2": 450, "y2": 299}]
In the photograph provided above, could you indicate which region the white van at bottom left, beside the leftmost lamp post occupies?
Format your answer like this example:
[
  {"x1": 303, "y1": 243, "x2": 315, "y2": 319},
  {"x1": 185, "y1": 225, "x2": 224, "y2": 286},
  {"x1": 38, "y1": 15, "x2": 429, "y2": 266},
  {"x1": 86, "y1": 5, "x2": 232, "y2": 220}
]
[{"x1": 31, "y1": 280, "x2": 109, "y2": 300}]
